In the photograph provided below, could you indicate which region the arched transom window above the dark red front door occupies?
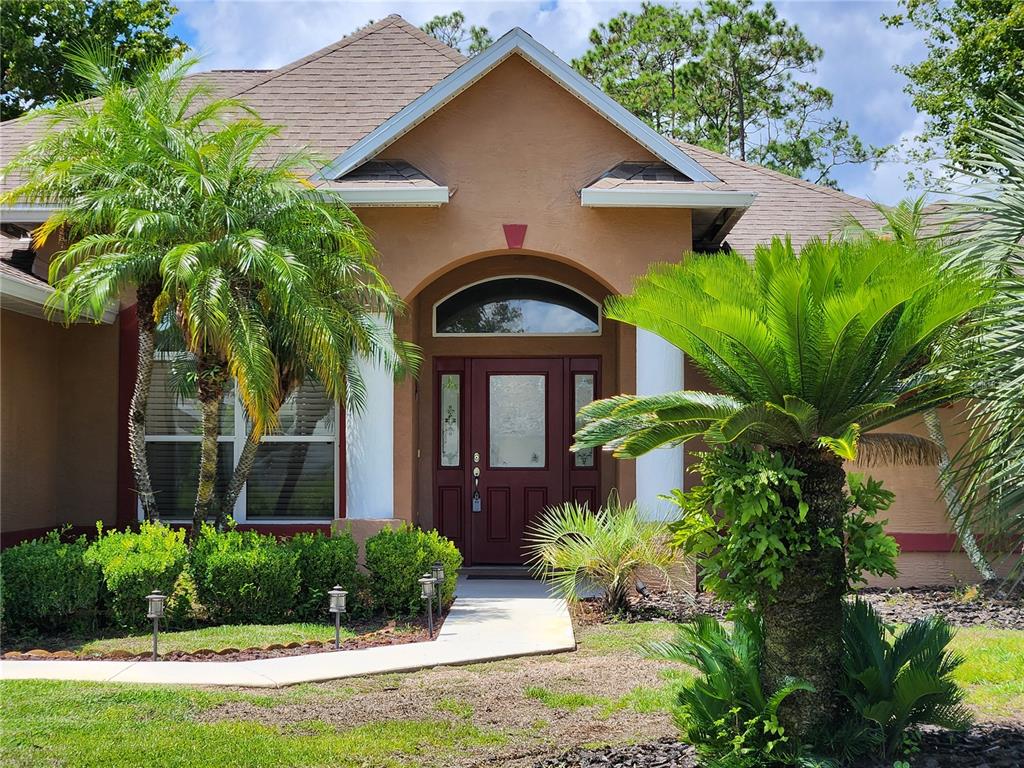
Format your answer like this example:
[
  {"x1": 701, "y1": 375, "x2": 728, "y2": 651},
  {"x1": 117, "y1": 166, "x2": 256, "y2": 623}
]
[{"x1": 434, "y1": 278, "x2": 601, "y2": 336}]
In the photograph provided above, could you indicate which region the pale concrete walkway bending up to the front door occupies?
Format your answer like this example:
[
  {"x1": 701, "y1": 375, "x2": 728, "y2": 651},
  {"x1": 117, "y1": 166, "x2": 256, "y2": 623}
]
[{"x1": 0, "y1": 579, "x2": 575, "y2": 687}]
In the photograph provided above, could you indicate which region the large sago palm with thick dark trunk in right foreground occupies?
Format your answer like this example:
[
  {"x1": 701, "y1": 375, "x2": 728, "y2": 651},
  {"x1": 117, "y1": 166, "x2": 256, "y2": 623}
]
[{"x1": 575, "y1": 239, "x2": 987, "y2": 738}]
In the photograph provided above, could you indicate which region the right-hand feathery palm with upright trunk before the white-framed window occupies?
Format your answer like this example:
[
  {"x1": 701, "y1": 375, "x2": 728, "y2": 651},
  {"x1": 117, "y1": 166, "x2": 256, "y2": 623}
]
[{"x1": 135, "y1": 119, "x2": 400, "y2": 536}]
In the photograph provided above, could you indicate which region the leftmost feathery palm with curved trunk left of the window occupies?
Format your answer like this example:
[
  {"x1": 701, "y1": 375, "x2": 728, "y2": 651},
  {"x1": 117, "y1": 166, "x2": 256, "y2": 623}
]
[{"x1": 0, "y1": 50, "x2": 242, "y2": 519}]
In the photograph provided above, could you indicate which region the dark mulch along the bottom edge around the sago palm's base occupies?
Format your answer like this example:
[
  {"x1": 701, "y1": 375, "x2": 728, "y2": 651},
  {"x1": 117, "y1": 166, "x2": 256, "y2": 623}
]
[{"x1": 536, "y1": 723, "x2": 1024, "y2": 768}]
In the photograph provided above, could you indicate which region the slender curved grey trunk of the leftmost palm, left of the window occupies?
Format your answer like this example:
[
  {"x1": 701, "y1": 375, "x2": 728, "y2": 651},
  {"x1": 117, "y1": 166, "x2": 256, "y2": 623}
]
[{"x1": 128, "y1": 285, "x2": 160, "y2": 520}]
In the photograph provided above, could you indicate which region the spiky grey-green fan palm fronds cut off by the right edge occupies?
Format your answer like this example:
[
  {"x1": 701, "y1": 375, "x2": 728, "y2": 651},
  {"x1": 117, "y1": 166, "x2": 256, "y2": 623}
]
[{"x1": 948, "y1": 97, "x2": 1024, "y2": 585}]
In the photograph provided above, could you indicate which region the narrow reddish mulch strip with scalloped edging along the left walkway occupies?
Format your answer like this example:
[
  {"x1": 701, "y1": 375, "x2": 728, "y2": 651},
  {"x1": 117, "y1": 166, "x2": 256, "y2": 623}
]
[{"x1": 3, "y1": 610, "x2": 447, "y2": 662}]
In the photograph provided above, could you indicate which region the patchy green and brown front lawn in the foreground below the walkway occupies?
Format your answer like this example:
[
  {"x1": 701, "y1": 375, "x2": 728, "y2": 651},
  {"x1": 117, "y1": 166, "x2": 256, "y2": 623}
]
[{"x1": 0, "y1": 624, "x2": 1024, "y2": 768}]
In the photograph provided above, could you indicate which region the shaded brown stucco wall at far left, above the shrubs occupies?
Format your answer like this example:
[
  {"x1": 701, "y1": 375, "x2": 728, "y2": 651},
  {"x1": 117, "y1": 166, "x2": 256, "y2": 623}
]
[{"x1": 0, "y1": 310, "x2": 118, "y2": 532}]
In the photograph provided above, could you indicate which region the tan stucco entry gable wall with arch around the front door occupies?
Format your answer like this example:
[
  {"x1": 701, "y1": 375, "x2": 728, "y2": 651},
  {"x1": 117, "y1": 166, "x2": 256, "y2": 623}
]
[{"x1": 357, "y1": 55, "x2": 691, "y2": 520}]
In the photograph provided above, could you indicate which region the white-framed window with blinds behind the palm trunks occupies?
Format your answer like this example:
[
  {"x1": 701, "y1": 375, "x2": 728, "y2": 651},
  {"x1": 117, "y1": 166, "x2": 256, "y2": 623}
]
[{"x1": 145, "y1": 353, "x2": 338, "y2": 522}]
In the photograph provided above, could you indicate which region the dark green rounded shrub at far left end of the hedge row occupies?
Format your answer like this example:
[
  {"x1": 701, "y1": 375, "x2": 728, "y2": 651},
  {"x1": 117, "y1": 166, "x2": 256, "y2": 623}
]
[{"x1": 0, "y1": 530, "x2": 100, "y2": 635}]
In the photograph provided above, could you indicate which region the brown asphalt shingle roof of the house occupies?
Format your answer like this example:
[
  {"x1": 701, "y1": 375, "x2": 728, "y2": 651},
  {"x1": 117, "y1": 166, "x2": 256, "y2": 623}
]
[{"x1": 0, "y1": 15, "x2": 882, "y2": 254}]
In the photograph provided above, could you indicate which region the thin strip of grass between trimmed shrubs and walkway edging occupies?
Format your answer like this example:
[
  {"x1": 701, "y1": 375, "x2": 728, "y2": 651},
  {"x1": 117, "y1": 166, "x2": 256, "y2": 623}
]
[{"x1": 73, "y1": 624, "x2": 355, "y2": 653}]
